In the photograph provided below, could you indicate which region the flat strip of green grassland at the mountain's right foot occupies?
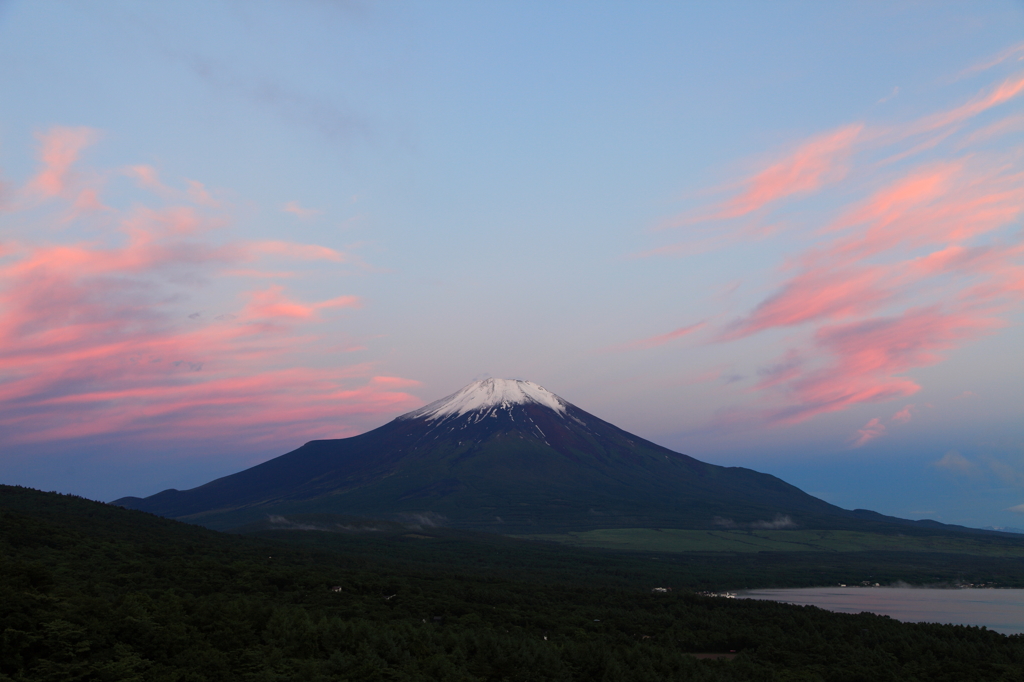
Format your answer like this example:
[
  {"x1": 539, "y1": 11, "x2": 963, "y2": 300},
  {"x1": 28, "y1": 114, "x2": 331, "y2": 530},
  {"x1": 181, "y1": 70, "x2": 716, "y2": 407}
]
[{"x1": 516, "y1": 528, "x2": 1024, "y2": 557}]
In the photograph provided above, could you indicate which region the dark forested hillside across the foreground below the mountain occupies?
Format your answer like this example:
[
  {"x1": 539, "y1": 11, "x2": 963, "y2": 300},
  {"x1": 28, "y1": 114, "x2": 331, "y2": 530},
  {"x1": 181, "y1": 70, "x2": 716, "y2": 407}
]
[{"x1": 0, "y1": 486, "x2": 1024, "y2": 682}]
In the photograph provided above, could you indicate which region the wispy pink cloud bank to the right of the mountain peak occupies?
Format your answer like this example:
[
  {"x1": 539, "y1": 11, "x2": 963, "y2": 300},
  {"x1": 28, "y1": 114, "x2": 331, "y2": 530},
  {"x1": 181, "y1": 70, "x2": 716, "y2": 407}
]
[{"x1": 642, "y1": 46, "x2": 1024, "y2": 436}]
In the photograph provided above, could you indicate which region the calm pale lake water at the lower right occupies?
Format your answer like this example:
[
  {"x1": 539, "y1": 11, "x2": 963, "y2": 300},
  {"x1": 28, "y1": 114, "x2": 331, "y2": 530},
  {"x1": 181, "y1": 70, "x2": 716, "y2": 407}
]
[{"x1": 736, "y1": 587, "x2": 1024, "y2": 635}]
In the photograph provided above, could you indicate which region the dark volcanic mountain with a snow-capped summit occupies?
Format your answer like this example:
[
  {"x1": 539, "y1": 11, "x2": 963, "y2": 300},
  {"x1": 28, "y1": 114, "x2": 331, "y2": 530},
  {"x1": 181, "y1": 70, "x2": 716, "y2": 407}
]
[{"x1": 114, "y1": 379, "x2": 895, "y2": 532}]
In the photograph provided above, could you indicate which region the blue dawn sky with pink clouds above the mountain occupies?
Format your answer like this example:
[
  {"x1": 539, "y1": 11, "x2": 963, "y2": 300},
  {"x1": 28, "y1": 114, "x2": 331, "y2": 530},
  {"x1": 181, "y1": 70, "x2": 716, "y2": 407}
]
[{"x1": 0, "y1": 0, "x2": 1024, "y2": 527}]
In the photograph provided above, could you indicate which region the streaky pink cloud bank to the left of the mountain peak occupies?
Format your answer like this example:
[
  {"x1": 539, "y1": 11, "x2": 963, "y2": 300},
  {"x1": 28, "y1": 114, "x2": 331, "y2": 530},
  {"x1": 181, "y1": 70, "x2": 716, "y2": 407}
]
[{"x1": 0, "y1": 128, "x2": 420, "y2": 456}]
